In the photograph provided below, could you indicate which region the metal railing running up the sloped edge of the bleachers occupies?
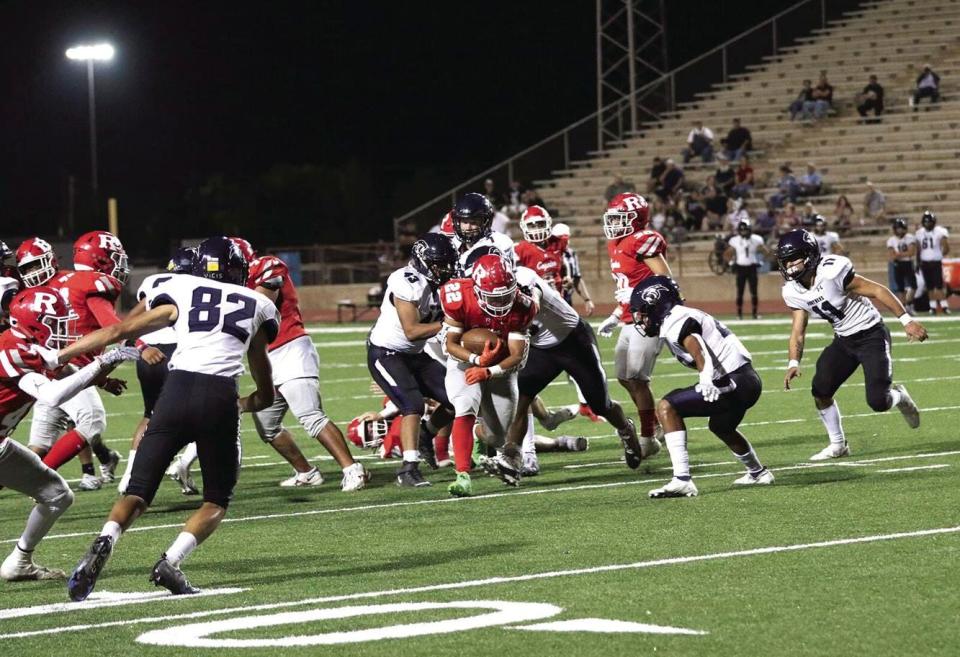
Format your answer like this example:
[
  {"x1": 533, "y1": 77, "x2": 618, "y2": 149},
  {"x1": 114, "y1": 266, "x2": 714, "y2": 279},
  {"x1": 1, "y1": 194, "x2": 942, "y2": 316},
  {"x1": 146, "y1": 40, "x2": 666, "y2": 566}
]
[{"x1": 394, "y1": 0, "x2": 863, "y2": 236}]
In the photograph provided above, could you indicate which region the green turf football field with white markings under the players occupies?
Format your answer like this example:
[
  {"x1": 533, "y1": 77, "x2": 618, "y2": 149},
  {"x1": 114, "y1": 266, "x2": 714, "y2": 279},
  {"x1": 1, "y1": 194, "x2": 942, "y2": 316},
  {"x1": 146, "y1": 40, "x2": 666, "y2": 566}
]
[{"x1": 0, "y1": 321, "x2": 960, "y2": 657}]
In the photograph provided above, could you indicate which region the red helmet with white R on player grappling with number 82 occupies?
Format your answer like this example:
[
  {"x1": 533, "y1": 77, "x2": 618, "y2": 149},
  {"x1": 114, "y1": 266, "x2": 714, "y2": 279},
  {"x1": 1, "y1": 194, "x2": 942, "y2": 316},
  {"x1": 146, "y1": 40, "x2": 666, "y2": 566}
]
[{"x1": 10, "y1": 285, "x2": 80, "y2": 349}]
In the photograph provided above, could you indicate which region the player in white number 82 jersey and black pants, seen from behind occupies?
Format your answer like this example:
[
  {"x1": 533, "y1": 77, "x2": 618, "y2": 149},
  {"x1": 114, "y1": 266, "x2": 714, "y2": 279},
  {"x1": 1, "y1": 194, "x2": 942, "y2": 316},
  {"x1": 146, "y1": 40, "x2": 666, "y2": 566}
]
[{"x1": 66, "y1": 237, "x2": 280, "y2": 601}]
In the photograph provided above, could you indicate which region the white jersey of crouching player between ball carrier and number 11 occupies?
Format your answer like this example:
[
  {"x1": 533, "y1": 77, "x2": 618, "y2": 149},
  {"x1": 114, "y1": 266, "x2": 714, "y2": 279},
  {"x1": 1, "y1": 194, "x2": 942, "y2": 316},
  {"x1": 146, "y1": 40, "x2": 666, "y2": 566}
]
[{"x1": 660, "y1": 306, "x2": 752, "y2": 381}]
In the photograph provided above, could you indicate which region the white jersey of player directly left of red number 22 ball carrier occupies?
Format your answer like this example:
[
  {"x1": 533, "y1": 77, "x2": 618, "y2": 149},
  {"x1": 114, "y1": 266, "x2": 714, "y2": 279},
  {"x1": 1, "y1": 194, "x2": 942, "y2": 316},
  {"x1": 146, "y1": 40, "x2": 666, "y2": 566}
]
[{"x1": 370, "y1": 265, "x2": 443, "y2": 354}]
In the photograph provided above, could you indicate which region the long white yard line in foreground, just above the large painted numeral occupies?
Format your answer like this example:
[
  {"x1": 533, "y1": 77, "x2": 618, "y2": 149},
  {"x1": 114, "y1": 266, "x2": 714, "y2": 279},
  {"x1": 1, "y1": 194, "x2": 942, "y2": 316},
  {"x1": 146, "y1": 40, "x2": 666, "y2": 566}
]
[{"x1": 0, "y1": 524, "x2": 960, "y2": 639}]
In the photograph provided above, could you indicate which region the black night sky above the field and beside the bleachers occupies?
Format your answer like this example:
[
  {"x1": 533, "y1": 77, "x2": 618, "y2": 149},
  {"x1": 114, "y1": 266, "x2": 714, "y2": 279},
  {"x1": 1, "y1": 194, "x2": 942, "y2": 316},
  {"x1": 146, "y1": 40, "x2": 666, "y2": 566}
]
[{"x1": 0, "y1": 0, "x2": 808, "y2": 256}]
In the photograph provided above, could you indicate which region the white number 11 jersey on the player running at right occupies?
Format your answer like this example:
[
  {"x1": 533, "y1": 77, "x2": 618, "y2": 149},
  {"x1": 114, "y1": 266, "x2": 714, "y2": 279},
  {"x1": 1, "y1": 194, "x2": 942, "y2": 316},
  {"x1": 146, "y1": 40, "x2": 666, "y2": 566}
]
[{"x1": 782, "y1": 255, "x2": 883, "y2": 335}]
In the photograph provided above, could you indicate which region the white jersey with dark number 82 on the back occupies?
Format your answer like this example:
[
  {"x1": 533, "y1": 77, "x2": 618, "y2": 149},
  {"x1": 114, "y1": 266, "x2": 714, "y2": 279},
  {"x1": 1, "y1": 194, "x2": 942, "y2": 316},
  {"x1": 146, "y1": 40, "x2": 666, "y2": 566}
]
[{"x1": 146, "y1": 274, "x2": 280, "y2": 377}]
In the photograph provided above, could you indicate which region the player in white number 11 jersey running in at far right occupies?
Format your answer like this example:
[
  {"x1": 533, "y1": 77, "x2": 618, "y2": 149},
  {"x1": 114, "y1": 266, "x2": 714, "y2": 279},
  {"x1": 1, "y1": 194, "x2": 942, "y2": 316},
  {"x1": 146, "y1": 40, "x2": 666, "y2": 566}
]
[{"x1": 777, "y1": 229, "x2": 927, "y2": 461}]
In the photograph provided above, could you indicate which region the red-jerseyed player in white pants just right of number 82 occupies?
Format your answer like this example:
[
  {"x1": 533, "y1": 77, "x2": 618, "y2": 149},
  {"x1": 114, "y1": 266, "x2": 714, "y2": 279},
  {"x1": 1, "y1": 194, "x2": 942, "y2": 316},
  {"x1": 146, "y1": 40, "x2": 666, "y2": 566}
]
[{"x1": 240, "y1": 237, "x2": 370, "y2": 492}]
